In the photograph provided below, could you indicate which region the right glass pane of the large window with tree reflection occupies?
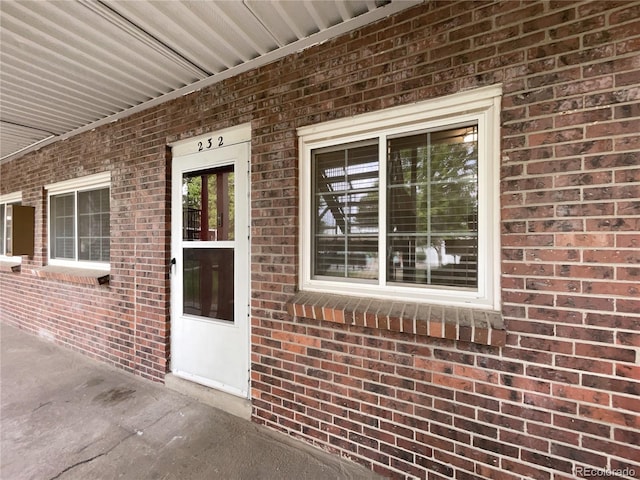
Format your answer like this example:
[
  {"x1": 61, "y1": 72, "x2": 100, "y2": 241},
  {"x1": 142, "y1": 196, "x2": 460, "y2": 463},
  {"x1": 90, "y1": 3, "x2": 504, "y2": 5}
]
[{"x1": 387, "y1": 126, "x2": 478, "y2": 288}]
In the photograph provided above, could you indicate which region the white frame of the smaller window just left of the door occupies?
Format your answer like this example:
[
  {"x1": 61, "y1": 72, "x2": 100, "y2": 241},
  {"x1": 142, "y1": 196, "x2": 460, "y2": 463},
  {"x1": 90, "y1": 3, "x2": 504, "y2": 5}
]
[{"x1": 44, "y1": 172, "x2": 111, "y2": 271}]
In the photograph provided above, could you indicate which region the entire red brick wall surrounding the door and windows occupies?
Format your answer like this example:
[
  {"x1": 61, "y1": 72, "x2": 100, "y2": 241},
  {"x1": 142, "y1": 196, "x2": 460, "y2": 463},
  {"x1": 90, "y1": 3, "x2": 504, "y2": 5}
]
[{"x1": 0, "y1": 1, "x2": 640, "y2": 480}]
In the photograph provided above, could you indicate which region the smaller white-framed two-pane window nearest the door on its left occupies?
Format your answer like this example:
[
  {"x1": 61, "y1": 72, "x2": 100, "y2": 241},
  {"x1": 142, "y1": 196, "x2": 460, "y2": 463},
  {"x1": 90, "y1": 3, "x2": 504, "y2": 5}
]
[{"x1": 46, "y1": 172, "x2": 110, "y2": 268}]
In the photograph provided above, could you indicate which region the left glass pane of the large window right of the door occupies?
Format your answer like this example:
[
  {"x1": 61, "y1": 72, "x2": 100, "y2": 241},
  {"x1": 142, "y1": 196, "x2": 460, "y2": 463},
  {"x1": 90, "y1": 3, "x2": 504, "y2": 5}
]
[{"x1": 312, "y1": 142, "x2": 379, "y2": 279}]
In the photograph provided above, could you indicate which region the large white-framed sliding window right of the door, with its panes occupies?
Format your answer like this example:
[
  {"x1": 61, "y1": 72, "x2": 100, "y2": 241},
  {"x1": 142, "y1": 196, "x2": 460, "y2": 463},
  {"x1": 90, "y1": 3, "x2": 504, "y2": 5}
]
[{"x1": 299, "y1": 87, "x2": 500, "y2": 308}]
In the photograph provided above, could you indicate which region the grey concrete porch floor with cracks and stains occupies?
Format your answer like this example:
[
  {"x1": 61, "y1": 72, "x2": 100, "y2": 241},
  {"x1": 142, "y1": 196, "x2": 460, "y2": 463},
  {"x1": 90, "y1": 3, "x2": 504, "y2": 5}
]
[{"x1": 0, "y1": 323, "x2": 380, "y2": 480}]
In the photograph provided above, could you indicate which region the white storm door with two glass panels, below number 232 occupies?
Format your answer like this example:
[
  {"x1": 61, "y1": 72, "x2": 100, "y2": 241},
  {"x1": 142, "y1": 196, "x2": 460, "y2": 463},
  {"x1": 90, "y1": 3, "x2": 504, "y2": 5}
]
[{"x1": 171, "y1": 143, "x2": 250, "y2": 398}]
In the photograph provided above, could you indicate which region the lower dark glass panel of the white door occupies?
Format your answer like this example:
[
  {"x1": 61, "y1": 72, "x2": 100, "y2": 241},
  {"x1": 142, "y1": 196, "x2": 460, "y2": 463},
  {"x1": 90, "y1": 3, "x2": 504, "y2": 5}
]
[{"x1": 182, "y1": 248, "x2": 234, "y2": 322}]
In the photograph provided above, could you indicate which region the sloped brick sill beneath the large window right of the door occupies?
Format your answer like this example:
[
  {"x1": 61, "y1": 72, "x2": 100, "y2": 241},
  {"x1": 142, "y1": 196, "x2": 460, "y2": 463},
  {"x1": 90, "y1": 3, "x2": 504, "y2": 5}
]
[{"x1": 287, "y1": 292, "x2": 507, "y2": 347}]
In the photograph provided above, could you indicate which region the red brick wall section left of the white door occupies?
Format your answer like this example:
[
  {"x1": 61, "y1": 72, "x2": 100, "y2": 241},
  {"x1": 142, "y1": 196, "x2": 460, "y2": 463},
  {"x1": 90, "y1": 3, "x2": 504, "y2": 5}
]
[{"x1": 0, "y1": 119, "x2": 170, "y2": 380}]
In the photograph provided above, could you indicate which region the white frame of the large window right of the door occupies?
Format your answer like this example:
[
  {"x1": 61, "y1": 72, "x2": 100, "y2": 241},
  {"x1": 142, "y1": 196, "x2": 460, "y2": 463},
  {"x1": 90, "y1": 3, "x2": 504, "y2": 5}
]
[{"x1": 297, "y1": 85, "x2": 502, "y2": 310}]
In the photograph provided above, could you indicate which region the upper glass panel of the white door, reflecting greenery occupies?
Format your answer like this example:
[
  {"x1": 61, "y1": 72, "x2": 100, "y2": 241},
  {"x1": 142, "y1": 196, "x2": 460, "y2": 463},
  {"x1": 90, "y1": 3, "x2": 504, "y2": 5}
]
[{"x1": 182, "y1": 166, "x2": 235, "y2": 241}]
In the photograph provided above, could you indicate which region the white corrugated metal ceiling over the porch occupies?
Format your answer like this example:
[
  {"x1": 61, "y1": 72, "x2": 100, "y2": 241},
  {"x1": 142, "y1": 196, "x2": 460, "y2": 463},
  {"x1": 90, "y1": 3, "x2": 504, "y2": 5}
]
[{"x1": 0, "y1": 0, "x2": 421, "y2": 160}]
